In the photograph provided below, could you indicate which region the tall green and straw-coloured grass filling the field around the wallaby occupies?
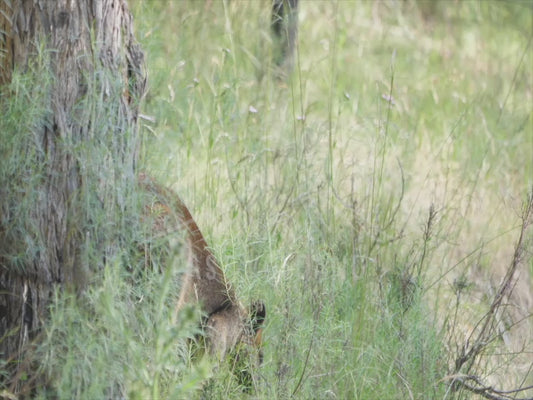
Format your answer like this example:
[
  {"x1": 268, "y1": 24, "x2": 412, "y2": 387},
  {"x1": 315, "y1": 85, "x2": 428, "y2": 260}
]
[{"x1": 0, "y1": 0, "x2": 533, "y2": 399}]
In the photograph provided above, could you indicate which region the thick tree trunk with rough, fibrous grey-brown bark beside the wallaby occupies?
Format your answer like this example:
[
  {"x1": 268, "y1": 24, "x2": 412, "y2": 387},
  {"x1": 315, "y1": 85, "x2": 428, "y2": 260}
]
[{"x1": 0, "y1": 0, "x2": 145, "y2": 388}]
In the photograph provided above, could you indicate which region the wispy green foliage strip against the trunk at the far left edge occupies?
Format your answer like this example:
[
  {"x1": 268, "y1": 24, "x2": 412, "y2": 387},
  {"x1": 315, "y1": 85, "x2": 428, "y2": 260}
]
[{"x1": 0, "y1": 48, "x2": 52, "y2": 269}]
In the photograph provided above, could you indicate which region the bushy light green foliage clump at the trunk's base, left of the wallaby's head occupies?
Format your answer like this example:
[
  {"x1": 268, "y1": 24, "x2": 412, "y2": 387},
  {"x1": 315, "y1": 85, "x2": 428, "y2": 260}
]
[{"x1": 33, "y1": 265, "x2": 211, "y2": 399}]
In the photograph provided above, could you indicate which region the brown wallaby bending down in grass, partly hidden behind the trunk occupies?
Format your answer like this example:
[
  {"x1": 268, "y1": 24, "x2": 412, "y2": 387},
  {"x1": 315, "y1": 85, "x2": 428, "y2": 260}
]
[{"x1": 139, "y1": 174, "x2": 266, "y2": 372}]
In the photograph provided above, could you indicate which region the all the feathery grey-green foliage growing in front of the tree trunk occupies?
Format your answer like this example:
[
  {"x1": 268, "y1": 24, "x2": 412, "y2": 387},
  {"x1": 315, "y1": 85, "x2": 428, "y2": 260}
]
[{"x1": 0, "y1": 39, "x2": 213, "y2": 399}]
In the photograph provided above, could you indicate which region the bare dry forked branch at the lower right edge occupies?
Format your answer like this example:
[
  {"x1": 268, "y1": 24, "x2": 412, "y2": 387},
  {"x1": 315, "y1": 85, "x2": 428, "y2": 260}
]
[{"x1": 451, "y1": 188, "x2": 533, "y2": 400}]
